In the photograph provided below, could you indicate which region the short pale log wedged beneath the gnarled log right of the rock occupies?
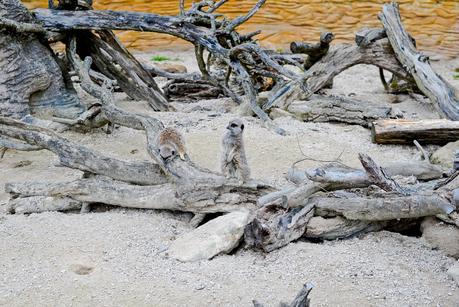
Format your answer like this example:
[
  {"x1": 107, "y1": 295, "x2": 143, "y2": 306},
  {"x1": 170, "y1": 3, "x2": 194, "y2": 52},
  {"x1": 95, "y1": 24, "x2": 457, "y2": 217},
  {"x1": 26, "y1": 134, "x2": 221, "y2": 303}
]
[{"x1": 303, "y1": 216, "x2": 387, "y2": 240}]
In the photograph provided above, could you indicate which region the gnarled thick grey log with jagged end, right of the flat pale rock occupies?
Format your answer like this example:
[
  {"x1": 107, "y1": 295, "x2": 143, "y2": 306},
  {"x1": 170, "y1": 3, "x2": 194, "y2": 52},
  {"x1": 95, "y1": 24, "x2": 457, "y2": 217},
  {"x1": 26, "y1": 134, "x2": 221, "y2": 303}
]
[{"x1": 245, "y1": 154, "x2": 456, "y2": 252}]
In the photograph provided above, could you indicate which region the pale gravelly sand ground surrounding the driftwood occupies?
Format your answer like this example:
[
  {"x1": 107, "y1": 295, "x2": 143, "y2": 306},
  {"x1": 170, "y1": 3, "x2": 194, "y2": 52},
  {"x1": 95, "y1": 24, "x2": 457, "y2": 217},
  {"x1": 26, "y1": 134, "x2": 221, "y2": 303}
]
[{"x1": 0, "y1": 53, "x2": 459, "y2": 307}]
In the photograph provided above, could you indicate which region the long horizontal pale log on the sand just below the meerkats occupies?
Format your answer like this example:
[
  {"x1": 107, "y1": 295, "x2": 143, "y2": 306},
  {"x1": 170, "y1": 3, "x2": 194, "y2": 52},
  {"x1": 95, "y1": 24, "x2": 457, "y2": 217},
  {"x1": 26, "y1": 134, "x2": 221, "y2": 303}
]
[{"x1": 5, "y1": 176, "x2": 271, "y2": 214}]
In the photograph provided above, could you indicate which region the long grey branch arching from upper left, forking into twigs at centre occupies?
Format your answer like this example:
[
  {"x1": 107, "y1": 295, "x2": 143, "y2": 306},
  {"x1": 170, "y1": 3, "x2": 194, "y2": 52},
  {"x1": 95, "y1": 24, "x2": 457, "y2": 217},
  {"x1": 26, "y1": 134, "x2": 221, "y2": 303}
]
[{"x1": 30, "y1": 6, "x2": 288, "y2": 134}]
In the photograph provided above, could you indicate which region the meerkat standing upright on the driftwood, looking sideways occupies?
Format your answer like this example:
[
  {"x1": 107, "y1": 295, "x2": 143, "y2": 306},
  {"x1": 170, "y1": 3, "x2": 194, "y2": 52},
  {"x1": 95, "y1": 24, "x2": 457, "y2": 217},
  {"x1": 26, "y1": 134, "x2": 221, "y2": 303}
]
[{"x1": 221, "y1": 119, "x2": 250, "y2": 182}]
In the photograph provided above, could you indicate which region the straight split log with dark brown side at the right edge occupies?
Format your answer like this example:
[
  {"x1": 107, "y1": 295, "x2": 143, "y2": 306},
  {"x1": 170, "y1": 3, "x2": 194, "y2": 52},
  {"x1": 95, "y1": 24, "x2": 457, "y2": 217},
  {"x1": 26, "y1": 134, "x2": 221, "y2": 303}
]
[{"x1": 371, "y1": 119, "x2": 459, "y2": 144}]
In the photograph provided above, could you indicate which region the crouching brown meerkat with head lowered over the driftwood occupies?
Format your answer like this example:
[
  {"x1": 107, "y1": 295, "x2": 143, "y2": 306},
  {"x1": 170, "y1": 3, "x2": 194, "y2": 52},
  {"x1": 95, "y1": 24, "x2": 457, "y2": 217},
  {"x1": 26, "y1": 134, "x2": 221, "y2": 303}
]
[{"x1": 158, "y1": 128, "x2": 186, "y2": 160}]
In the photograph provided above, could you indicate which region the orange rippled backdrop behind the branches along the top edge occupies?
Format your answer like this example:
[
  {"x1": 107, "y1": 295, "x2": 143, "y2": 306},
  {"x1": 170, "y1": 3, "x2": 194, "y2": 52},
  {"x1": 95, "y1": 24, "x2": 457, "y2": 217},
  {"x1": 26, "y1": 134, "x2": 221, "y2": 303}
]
[{"x1": 23, "y1": 0, "x2": 459, "y2": 57}]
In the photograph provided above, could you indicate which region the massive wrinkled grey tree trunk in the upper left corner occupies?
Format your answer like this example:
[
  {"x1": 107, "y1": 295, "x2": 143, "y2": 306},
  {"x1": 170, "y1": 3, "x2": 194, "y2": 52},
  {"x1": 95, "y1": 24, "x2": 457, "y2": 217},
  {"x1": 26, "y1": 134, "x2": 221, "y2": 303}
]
[{"x1": 0, "y1": 0, "x2": 85, "y2": 118}]
